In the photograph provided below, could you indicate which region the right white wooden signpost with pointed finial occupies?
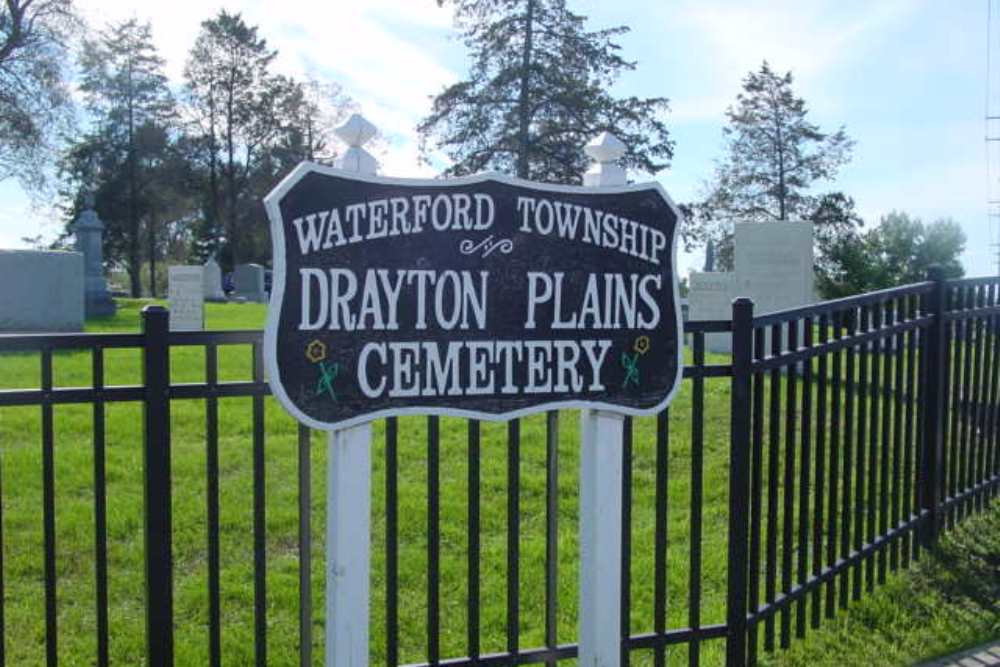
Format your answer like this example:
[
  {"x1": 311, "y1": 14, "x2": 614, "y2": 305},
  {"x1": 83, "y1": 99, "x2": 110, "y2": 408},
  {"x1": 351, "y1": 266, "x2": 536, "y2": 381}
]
[{"x1": 579, "y1": 132, "x2": 626, "y2": 667}]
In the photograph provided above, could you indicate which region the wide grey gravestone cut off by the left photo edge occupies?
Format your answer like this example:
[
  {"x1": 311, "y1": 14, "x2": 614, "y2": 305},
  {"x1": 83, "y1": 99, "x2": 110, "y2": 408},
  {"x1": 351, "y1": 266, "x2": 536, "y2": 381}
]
[{"x1": 0, "y1": 250, "x2": 84, "y2": 332}]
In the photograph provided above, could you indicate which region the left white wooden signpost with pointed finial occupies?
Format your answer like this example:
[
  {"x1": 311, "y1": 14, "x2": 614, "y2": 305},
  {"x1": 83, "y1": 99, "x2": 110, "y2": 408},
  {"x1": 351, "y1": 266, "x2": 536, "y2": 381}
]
[{"x1": 326, "y1": 114, "x2": 376, "y2": 667}]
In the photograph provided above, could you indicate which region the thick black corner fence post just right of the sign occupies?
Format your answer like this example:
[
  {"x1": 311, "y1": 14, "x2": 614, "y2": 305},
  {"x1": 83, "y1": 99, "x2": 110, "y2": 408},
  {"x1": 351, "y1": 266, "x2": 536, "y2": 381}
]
[{"x1": 726, "y1": 297, "x2": 753, "y2": 667}]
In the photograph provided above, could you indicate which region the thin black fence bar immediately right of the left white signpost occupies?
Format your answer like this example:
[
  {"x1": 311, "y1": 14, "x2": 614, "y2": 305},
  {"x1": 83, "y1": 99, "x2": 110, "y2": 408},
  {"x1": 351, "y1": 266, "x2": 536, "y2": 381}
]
[{"x1": 385, "y1": 417, "x2": 398, "y2": 667}]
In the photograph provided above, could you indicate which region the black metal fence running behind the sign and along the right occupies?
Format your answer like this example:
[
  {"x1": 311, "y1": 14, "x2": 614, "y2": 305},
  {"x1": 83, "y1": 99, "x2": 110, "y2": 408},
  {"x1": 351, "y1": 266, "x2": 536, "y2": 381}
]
[{"x1": 0, "y1": 278, "x2": 1000, "y2": 667}]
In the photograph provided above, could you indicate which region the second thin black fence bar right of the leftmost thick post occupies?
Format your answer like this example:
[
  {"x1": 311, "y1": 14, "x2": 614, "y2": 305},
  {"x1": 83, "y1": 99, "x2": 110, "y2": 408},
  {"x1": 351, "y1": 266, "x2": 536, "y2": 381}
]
[{"x1": 252, "y1": 343, "x2": 267, "y2": 667}]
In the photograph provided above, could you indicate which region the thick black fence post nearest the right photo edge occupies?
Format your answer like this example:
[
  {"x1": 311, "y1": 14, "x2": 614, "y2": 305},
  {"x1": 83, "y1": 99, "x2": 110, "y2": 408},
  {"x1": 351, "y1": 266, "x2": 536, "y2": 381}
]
[{"x1": 917, "y1": 266, "x2": 948, "y2": 548}]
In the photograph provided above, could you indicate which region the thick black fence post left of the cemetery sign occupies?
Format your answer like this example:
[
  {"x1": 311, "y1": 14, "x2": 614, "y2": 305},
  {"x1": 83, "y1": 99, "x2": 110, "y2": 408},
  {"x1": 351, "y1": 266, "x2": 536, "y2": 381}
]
[{"x1": 142, "y1": 306, "x2": 174, "y2": 667}]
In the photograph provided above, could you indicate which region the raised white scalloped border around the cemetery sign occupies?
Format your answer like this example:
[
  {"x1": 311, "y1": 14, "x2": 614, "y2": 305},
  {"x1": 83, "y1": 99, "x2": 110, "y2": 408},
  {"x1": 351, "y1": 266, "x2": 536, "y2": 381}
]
[{"x1": 263, "y1": 161, "x2": 684, "y2": 431}]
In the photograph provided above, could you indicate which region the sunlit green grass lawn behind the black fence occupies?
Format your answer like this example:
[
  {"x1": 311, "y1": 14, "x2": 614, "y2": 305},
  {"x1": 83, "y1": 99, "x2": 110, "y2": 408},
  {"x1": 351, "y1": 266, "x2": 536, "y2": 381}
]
[{"x1": 0, "y1": 300, "x2": 996, "y2": 665}]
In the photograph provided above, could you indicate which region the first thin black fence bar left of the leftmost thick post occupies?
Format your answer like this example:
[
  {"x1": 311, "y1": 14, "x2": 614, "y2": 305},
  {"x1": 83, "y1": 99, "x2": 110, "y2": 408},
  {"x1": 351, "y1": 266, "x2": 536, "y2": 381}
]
[{"x1": 92, "y1": 345, "x2": 108, "y2": 667}]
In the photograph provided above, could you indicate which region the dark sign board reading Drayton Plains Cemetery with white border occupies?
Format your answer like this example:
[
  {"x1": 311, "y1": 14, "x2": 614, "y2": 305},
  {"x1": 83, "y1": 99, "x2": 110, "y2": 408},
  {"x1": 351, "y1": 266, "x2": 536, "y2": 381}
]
[{"x1": 265, "y1": 163, "x2": 682, "y2": 429}]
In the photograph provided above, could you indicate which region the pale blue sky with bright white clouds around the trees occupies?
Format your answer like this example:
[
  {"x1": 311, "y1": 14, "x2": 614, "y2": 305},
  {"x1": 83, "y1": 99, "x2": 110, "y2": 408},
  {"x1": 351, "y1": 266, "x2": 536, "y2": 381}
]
[{"x1": 0, "y1": 0, "x2": 1000, "y2": 275}]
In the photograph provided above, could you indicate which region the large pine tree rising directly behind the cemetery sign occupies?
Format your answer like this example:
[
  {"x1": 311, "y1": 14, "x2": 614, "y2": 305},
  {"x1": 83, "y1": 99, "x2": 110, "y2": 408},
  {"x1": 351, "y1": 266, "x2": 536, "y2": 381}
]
[{"x1": 417, "y1": 0, "x2": 673, "y2": 183}]
